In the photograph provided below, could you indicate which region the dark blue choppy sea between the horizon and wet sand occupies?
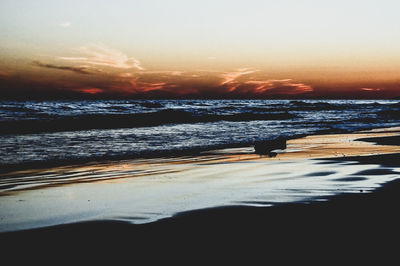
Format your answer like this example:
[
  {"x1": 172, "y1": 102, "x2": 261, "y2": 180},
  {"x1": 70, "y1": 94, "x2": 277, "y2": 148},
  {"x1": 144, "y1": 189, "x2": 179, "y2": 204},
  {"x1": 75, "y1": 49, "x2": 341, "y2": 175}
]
[{"x1": 0, "y1": 100, "x2": 400, "y2": 172}]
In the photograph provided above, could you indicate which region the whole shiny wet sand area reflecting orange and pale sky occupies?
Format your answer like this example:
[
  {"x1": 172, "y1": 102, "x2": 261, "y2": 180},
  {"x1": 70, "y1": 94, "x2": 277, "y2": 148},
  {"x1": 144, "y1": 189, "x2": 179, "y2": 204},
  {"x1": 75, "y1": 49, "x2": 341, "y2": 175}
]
[{"x1": 0, "y1": 128, "x2": 400, "y2": 231}]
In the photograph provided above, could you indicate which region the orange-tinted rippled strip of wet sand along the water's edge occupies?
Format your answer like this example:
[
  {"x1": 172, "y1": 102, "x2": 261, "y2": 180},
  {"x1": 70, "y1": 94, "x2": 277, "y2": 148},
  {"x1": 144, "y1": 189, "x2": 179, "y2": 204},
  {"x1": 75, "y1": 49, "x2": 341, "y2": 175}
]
[{"x1": 0, "y1": 128, "x2": 400, "y2": 195}]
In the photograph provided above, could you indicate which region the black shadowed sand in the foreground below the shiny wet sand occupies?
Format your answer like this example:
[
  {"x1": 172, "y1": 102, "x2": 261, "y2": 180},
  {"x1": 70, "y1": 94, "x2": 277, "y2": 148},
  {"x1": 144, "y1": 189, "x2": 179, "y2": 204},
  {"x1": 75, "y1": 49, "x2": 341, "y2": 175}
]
[{"x1": 0, "y1": 130, "x2": 400, "y2": 260}]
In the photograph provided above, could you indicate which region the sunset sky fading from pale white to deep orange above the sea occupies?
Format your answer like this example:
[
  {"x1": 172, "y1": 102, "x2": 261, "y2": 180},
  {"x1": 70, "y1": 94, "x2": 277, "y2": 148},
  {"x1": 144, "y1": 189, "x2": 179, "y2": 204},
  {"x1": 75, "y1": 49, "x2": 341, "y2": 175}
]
[{"x1": 0, "y1": 0, "x2": 400, "y2": 98}]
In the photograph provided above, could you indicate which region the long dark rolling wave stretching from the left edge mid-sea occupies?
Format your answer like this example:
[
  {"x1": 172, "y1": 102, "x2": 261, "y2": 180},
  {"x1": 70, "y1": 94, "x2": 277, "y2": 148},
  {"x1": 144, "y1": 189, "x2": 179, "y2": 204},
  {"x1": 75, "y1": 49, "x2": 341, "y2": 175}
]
[{"x1": 0, "y1": 109, "x2": 297, "y2": 134}]
